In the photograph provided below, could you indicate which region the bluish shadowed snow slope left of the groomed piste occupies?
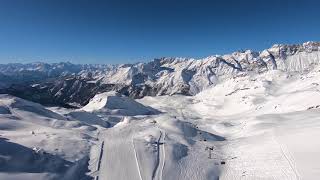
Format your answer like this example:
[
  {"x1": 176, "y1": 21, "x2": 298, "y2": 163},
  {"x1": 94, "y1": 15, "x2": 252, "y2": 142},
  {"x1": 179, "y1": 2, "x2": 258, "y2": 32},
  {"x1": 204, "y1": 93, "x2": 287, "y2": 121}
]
[{"x1": 0, "y1": 95, "x2": 101, "y2": 179}]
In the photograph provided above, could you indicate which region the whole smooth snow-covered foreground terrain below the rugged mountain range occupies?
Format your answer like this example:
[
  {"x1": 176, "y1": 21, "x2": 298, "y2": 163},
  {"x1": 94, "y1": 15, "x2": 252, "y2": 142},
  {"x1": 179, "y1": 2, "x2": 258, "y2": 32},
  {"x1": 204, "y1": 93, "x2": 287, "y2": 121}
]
[{"x1": 0, "y1": 62, "x2": 320, "y2": 180}]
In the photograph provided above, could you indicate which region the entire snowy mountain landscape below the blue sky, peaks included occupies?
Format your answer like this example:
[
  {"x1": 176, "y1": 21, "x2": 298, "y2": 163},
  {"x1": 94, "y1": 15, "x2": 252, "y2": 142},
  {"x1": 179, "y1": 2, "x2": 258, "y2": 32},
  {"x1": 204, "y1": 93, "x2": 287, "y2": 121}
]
[{"x1": 0, "y1": 42, "x2": 320, "y2": 180}]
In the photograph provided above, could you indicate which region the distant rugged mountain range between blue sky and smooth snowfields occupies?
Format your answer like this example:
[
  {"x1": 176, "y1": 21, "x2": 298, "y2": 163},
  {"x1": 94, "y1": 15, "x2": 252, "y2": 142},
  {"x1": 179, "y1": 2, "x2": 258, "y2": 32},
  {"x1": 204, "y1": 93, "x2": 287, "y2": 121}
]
[{"x1": 0, "y1": 42, "x2": 320, "y2": 105}]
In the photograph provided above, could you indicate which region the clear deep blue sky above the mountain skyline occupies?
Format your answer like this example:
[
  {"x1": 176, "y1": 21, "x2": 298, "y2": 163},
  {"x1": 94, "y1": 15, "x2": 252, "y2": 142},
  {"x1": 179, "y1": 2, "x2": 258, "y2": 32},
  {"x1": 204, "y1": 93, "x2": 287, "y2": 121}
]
[{"x1": 0, "y1": 0, "x2": 320, "y2": 64}]
